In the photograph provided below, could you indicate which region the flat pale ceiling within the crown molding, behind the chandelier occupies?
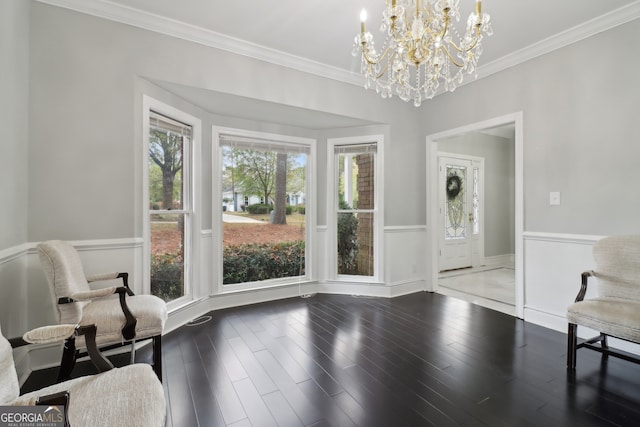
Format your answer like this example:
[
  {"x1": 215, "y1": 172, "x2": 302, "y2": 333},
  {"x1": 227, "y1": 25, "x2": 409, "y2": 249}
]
[{"x1": 105, "y1": 0, "x2": 638, "y2": 72}]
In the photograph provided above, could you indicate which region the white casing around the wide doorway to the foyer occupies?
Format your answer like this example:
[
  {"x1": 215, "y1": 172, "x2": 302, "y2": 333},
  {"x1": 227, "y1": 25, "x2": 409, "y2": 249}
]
[{"x1": 425, "y1": 111, "x2": 524, "y2": 319}]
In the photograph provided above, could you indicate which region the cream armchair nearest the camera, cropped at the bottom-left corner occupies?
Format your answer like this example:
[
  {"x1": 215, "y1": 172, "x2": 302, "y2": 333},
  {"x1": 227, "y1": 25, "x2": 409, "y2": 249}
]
[{"x1": 0, "y1": 325, "x2": 166, "y2": 427}]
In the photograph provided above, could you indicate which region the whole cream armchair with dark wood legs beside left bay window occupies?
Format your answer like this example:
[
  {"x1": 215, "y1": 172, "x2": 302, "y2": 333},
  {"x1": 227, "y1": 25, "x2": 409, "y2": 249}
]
[{"x1": 38, "y1": 240, "x2": 167, "y2": 381}]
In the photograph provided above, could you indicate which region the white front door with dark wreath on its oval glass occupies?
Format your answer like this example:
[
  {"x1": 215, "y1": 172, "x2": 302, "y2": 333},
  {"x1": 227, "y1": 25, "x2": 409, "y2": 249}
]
[{"x1": 438, "y1": 153, "x2": 484, "y2": 271}]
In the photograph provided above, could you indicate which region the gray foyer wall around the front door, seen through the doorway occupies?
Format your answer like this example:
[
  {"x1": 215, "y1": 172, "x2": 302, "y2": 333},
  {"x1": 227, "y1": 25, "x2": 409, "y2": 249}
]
[{"x1": 438, "y1": 133, "x2": 515, "y2": 257}]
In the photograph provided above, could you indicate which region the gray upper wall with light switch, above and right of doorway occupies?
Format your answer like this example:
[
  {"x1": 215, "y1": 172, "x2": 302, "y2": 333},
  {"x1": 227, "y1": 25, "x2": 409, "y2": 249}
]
[{"x1": 422, "y1": 20, "x2": 640, "y2": 235}]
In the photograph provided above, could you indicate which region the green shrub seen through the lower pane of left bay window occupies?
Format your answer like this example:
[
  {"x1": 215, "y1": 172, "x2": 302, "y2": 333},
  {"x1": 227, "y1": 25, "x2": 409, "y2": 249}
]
[{"x1": 151, "y1": 254, "x2": 183, "y2": 301}]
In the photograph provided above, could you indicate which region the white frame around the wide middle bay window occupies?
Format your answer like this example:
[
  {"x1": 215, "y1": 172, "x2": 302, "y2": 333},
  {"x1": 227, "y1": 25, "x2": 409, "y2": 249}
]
[{"x1": 211, "y1": 125, "x2": 317, "y2": 294}]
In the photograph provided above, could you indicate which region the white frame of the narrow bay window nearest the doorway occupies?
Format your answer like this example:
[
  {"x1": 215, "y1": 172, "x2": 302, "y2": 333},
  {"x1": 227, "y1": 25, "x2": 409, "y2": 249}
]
[{"x1": 326, "y1": 135, "x2": 384, "y2": 284}]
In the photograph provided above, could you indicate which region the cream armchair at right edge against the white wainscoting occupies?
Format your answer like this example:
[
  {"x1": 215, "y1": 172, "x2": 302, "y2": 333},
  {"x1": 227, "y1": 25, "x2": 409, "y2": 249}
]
[{"x1": 567, "y1": 236, "x2": 640, "y2": 370}]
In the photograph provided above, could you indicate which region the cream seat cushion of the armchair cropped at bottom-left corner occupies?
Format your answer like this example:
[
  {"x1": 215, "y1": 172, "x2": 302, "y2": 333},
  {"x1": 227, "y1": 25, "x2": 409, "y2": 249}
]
[{"x1": 10, "y1": 363, "x2": 166, "y2": 427}]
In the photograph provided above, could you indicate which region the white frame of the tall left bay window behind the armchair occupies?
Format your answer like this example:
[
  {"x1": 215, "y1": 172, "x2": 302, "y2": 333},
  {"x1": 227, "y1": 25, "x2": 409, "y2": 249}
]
[{"x1": 142, "y1": 94, "x2": 202, "y2": 312}]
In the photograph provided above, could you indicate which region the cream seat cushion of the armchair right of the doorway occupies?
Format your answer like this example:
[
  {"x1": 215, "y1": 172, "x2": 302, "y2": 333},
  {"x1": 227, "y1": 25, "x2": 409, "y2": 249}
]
[{"x1": 567, "y1": 297, "x2": 640, "y2": 342}]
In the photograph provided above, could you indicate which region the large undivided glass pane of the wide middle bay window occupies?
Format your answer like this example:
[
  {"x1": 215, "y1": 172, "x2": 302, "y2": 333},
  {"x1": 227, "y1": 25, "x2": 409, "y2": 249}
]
[{"x1": 221, "y1": 143, "x2": 307, "y2": 285}]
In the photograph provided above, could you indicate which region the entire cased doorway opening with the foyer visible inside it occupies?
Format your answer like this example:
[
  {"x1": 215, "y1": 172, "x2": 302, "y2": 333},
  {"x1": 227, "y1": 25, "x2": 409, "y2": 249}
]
[{"x1": 427, "y1": 113, "x2": 524, "y2": 318}]
